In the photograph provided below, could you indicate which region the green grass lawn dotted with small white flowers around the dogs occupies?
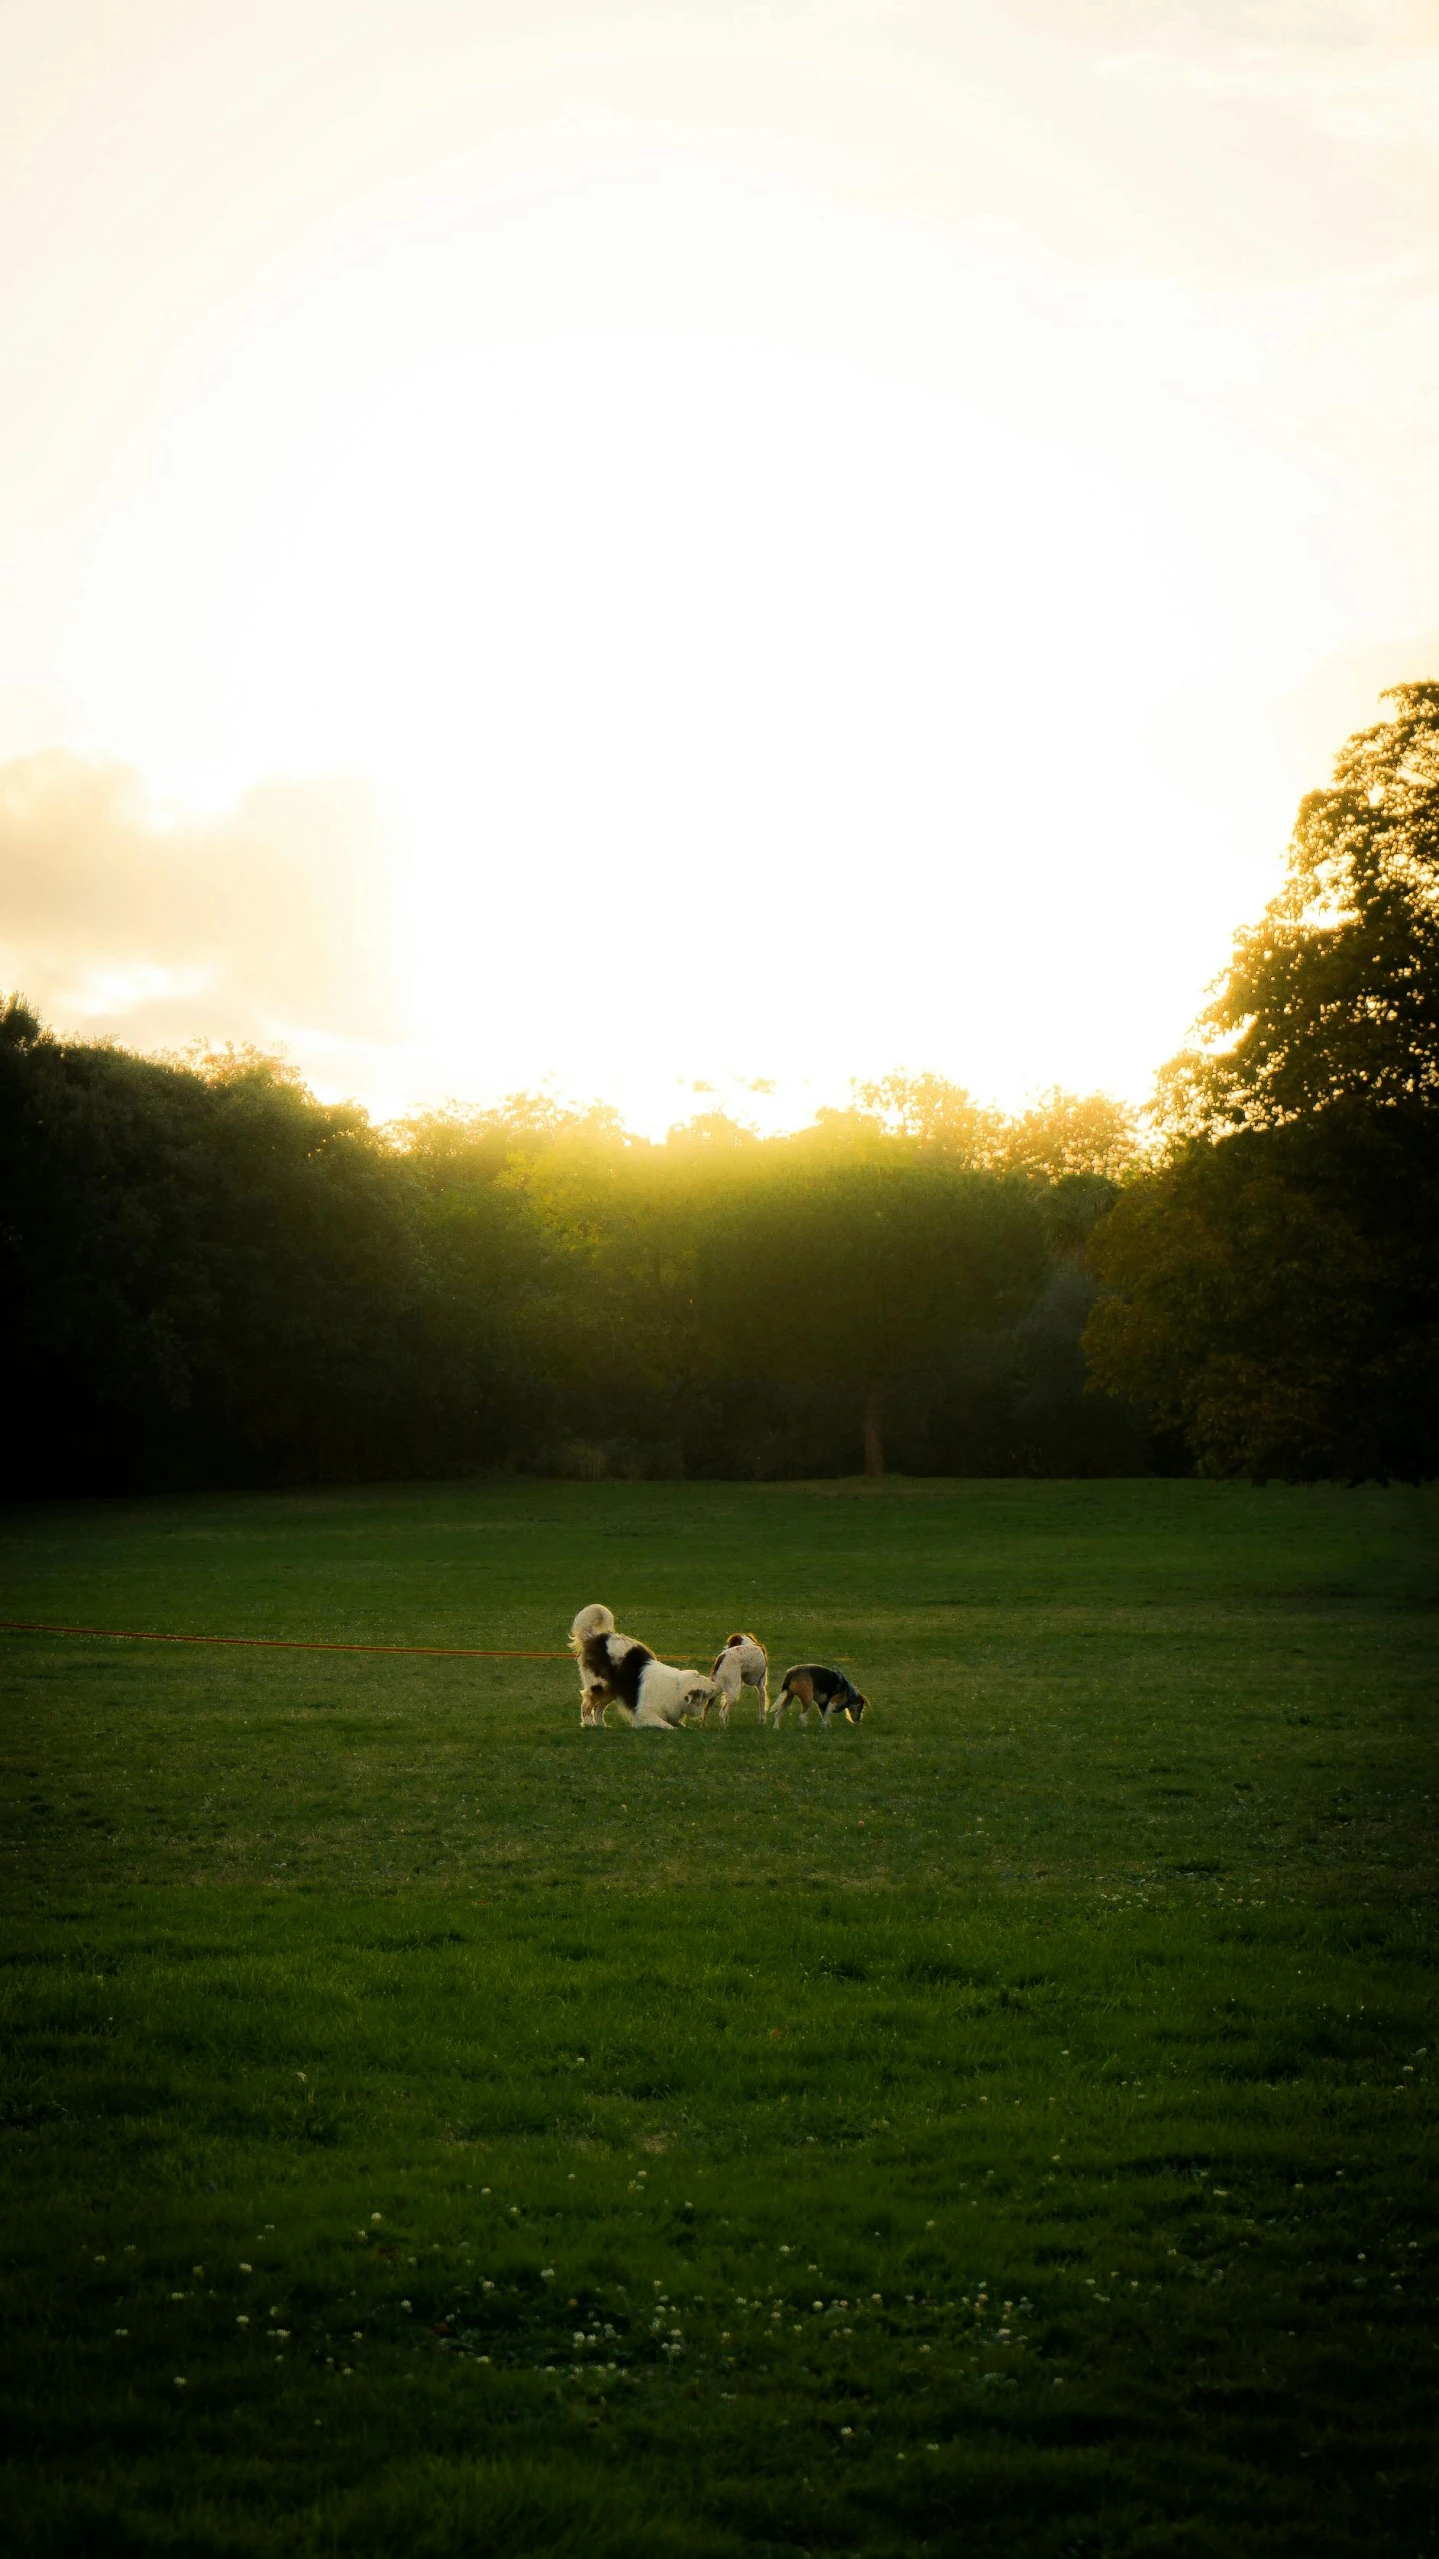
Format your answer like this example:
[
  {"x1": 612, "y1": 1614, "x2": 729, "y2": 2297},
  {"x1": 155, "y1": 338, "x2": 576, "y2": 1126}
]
[{"x1": 0, "y1": 1482, "x2": 1439, "y2": 2559}]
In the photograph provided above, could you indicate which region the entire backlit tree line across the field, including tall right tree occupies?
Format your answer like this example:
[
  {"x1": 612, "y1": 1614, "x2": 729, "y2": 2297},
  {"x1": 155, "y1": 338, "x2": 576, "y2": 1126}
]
[{"x1": 0, "y1": 686, "x2": 1439, "y2": 1497}]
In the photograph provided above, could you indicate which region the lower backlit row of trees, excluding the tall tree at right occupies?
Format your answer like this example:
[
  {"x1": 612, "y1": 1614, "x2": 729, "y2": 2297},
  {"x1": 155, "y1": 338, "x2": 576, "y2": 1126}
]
[{"x1": 0, "y1": 1003, "x2": 1147, "y2": 1494}]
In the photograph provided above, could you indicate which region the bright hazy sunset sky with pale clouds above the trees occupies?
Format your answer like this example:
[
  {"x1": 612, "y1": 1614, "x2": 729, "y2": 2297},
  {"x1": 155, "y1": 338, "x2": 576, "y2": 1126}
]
[{"x1": 0, "y1": 0, "x2": 1439, "y2": 1131}]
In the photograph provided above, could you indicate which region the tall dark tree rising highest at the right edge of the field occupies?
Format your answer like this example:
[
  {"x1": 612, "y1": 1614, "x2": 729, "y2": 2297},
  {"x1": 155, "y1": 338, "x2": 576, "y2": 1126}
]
[{"x1": 1086, "y1": 683, "x2": 1439, "y2": 1482}]
